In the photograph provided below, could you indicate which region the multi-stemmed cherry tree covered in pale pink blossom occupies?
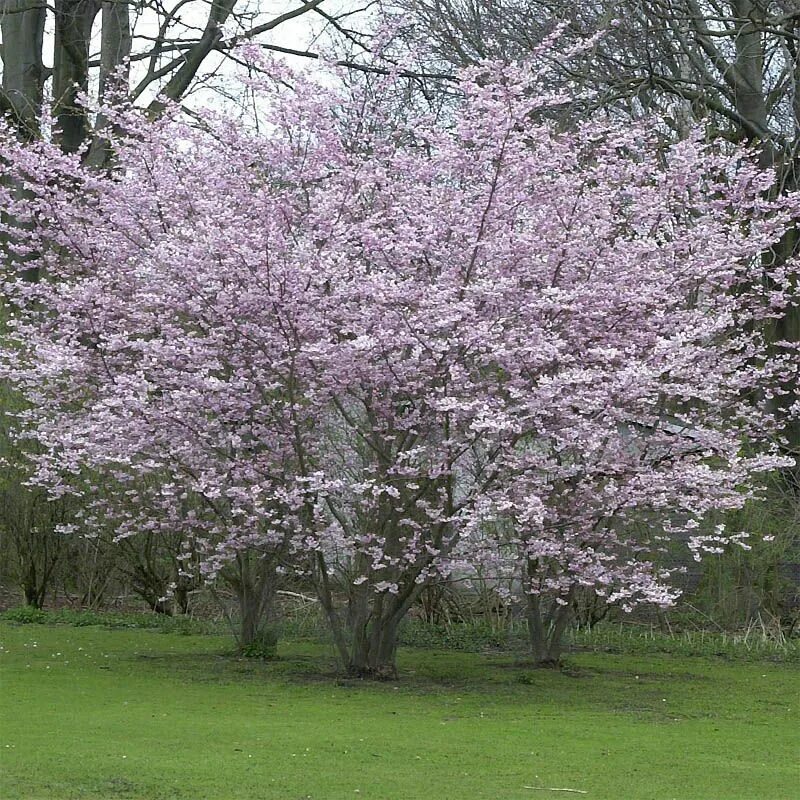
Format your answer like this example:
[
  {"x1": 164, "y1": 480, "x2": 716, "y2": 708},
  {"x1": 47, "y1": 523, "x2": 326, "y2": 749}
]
[{"x1": 2, "y1": 56, "x2": 797, "y2": 677}]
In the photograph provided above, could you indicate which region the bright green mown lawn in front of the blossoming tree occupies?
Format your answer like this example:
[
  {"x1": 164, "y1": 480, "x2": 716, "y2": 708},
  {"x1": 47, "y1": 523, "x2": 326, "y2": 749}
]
[{"x1": 0, "y1": 623, "x2": 800, "y2": 800}]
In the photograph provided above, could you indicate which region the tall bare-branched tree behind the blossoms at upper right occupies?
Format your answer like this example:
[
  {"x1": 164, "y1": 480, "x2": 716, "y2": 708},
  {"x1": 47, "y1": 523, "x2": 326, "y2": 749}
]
[{"x1": 396, "y1": 0, "x2": 800, "y2": 476}]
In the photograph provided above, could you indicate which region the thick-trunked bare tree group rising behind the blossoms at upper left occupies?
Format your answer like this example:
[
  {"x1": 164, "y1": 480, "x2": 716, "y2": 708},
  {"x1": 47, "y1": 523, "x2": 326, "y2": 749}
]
[{"x1": 0, "y1": 0, "x2": 376, "y2": 152}]
